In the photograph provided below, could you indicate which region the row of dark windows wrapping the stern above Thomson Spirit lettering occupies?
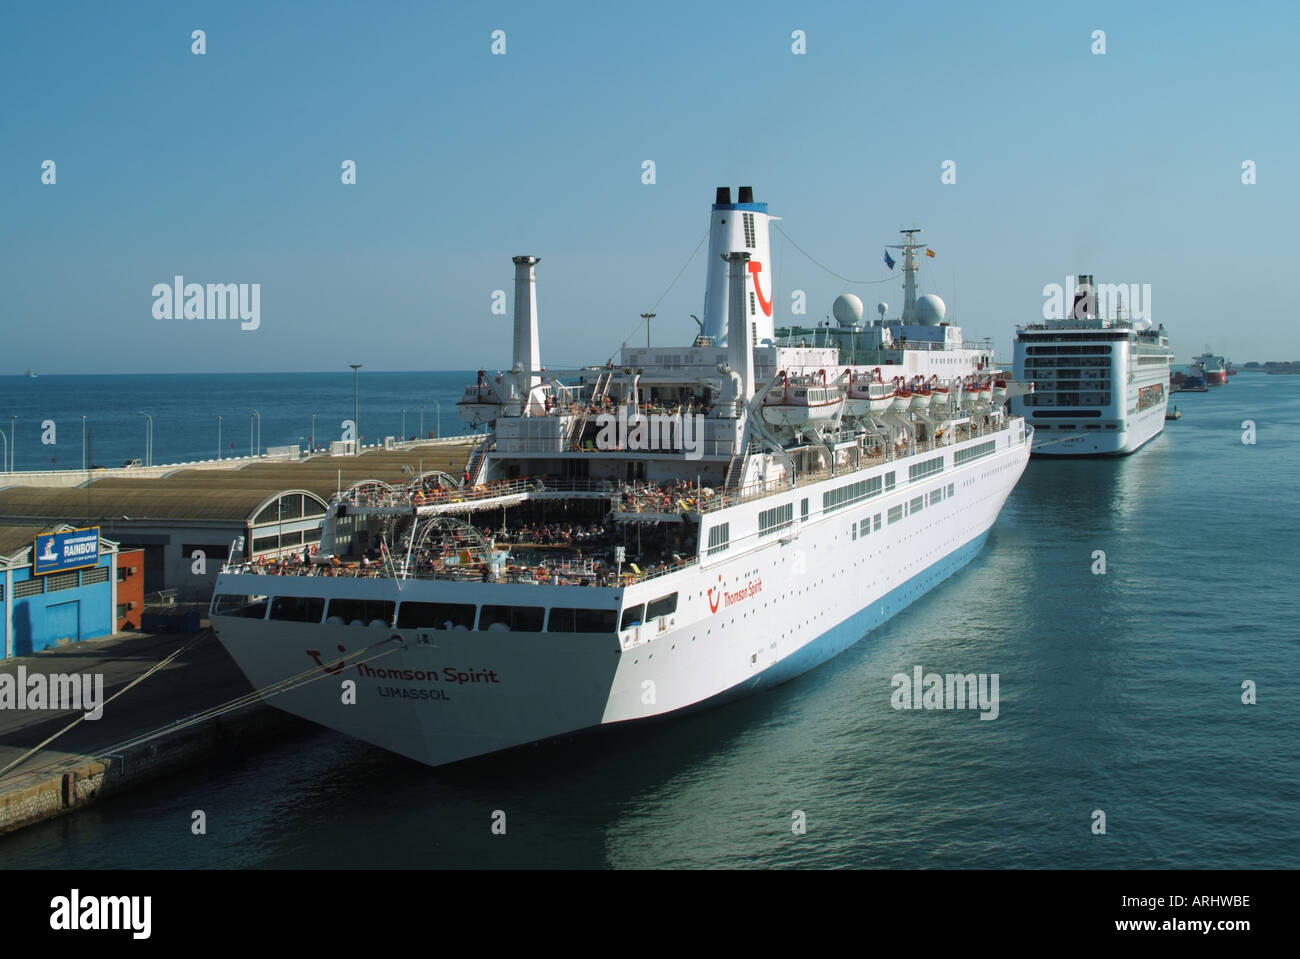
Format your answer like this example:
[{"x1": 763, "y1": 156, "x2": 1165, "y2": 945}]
[{"x1": 213, "y1": 593, "x2": 677, "y2": 633}]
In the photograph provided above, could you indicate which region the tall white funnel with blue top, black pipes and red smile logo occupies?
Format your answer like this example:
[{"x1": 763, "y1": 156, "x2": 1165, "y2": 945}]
[{"x1": 702, "y1": 187, "x2": 777, "y2": 346}]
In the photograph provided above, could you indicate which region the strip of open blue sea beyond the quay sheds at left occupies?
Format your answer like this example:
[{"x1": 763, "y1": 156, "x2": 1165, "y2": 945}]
[{"x1": 0, "y1": 369, "x2": 475, "y2": 470}]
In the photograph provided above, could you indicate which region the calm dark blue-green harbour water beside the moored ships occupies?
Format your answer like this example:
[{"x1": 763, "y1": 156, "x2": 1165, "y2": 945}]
[{"x1": 0, "y1": 374, "x2": 1300, "y2": 869}]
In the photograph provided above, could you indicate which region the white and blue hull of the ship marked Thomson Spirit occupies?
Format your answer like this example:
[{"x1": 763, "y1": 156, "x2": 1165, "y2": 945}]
[{"x1": 212, "y1": 430, "x2": 1032, "y2": 765}]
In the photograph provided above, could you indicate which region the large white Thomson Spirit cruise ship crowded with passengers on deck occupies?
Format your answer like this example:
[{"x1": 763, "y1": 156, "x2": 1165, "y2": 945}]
[{"x1": 211, "y1": 187, "x2": 1032, "y2": 765}]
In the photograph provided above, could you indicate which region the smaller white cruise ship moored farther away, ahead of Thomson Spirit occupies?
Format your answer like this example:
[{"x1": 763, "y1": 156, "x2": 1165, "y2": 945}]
[{"x1": 1011, "y1": 275, "x2": 1174, "y2": 456}]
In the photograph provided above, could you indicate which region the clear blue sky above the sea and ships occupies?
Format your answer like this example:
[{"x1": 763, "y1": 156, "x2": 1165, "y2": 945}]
[{"x1": 0, "y1": 3, "x2": 1300, "y2": 373}]
